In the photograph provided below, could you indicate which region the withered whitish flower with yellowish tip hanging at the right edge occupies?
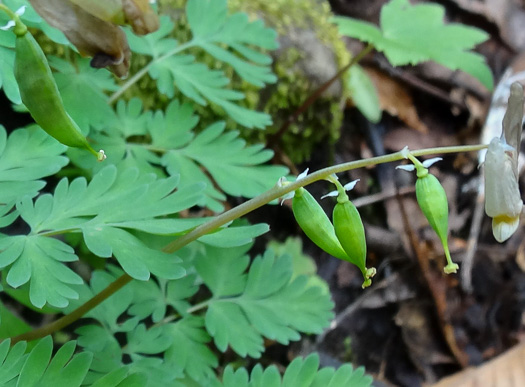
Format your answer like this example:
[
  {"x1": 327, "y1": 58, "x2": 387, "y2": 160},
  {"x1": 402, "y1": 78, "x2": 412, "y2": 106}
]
[{"x1": 484, "y1": 82, "x2": 523, "y2": 242}]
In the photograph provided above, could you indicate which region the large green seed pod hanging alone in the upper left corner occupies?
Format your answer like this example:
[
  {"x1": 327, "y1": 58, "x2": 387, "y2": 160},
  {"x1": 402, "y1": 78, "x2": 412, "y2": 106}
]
[{"x1": 0, "y1": 4, "x2": 106, "y2": 161}]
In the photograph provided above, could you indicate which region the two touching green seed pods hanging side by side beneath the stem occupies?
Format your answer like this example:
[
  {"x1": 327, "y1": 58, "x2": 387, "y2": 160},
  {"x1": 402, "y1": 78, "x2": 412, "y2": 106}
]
[{"x1": 292, "y1": 182, "x2": 375, "y2": 288}]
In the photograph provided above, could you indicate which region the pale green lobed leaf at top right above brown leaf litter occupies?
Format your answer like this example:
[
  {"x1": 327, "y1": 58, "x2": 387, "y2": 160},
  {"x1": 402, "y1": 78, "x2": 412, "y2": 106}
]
[{"x1": 334, "y1": 0, "x2": 494, "y2": 90}]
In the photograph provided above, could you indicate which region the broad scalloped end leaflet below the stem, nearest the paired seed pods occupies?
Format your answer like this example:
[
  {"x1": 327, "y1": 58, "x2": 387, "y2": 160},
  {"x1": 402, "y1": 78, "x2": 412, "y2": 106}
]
[{"x1": 196, "y1": 250, "x2": 333, "y2": 357}]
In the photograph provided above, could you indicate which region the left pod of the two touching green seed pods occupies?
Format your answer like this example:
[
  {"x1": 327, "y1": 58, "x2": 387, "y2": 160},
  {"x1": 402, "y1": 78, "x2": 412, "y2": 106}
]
[{"x1": 292, "y1": 188, "x2": 348, "y2": 260}]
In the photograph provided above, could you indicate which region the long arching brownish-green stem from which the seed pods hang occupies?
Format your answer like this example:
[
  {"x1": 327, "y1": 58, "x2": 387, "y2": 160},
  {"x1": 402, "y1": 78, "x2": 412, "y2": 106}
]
[{"x1": 11, "y1": 144, "x2": 488, "y2": 345}]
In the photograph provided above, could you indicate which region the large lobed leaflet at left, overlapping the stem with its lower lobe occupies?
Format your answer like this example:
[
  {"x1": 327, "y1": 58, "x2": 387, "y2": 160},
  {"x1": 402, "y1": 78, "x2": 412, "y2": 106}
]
[{"x1": 14, "y1": 166, "x2": 202, "y2": 284}]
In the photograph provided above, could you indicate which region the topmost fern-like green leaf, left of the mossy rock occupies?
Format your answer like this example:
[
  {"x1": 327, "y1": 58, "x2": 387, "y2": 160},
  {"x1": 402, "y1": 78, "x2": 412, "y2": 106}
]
[{"x1": 124, "y1": 0, "x2": 277, "y2": 129}]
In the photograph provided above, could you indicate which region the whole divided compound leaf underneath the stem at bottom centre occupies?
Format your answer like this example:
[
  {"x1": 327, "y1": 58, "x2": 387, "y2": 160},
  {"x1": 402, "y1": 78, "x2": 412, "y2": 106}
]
[{"x1": 58, "y1": 245, "x2": 333, "y2": 386}]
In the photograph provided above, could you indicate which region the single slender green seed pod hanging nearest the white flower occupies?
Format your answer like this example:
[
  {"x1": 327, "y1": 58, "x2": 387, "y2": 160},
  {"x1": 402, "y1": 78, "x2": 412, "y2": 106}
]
[{"x1": 416, "y1": 168, "x2": 458, "y2": 274}]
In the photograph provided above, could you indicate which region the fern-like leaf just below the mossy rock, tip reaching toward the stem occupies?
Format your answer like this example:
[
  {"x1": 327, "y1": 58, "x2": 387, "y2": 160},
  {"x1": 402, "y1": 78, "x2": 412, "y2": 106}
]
[{"x1": 78, "y1": 99, "x2": 288, "y2": 212}]
